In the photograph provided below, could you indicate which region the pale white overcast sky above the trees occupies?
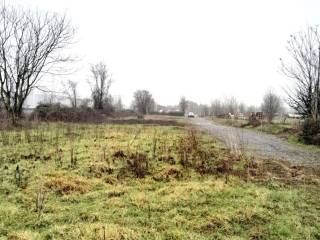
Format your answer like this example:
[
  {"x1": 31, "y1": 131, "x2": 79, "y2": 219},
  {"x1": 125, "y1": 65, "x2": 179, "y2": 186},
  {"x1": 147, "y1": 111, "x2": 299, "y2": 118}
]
[{"x1": 11, "y1": 0, "x2": 320, "y2": 105}]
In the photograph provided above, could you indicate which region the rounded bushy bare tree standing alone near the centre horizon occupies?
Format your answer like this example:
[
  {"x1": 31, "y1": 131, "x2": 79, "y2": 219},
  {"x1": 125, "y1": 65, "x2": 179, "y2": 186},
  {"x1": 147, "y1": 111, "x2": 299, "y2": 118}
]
[{"x1": 132, "y1": 90, "x2": 155, "y2": 114}]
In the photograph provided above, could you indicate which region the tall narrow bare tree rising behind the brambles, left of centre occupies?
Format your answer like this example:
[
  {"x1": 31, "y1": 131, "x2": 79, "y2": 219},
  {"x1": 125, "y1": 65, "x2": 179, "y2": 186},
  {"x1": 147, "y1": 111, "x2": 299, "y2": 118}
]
[{"x1": 90, "y1": 62, "x2": 112, "y2": 109}]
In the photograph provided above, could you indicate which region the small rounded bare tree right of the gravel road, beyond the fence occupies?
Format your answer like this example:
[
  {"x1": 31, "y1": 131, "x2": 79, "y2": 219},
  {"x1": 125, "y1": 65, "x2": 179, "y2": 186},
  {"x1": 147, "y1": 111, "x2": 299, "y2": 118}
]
[{"x1": 261, "y1": 90, "x2": 281, "y2": 123}]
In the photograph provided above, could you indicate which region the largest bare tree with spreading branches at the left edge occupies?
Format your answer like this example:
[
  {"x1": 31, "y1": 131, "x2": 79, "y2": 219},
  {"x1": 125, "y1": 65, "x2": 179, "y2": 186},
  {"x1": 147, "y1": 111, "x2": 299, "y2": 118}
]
[{"x1": 0, "y1": 5, "x2": 74, "y2": 123}]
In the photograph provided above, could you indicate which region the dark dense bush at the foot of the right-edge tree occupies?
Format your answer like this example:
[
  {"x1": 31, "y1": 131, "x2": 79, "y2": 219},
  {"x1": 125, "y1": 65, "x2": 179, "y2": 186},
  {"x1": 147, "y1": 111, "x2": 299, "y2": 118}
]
[{"x1": 300, "y1": 118, "x2": 320, "y2": 145}]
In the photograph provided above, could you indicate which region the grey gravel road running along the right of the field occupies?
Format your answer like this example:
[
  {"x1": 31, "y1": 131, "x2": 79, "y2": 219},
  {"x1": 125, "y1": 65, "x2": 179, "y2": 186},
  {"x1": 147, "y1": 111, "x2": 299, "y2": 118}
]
[{"x1": 191, "y1": 118, "x2": 320, "y2": 166}]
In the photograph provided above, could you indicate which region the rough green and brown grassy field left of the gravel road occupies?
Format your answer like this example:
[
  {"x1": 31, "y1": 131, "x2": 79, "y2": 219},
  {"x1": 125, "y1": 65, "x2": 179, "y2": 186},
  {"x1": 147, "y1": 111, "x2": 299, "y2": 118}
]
[{"x1": 0, "y1": 123, "x2": 320, "y2": 240}]
